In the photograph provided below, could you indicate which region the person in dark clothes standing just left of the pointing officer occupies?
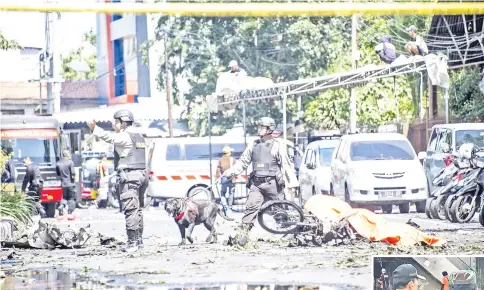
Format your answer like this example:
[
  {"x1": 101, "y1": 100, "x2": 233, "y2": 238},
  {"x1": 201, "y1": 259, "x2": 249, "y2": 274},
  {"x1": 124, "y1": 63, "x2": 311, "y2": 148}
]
[{"x1": 55, "y1": 150, "x2": 76, "y2": 220}]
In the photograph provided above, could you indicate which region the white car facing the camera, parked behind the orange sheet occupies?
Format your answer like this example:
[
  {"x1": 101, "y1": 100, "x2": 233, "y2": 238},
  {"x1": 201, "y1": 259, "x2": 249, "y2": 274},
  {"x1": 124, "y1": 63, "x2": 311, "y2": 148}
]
[{"x1": 330, "y1": 133, "x2": 428, "y2": 213}]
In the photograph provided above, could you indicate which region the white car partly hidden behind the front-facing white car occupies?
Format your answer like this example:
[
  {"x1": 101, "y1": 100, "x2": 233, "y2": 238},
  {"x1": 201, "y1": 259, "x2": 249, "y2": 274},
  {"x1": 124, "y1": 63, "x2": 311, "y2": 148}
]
[{"x1": 299, "y1": 136, "x2": 340, "y2": 201}]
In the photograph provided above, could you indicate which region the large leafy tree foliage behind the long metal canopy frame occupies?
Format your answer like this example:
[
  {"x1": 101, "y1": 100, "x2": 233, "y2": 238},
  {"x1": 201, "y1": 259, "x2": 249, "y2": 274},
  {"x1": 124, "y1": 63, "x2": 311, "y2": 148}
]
[{"x1": 151, "y1": 8, "x2": 428, "y2": 135}]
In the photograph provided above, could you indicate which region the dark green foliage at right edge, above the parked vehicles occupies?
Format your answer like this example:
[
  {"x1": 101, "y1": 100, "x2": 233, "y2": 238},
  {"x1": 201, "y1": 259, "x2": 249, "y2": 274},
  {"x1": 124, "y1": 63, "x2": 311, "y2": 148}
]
[{"x1": 449, "y1": 67, "x2": 484, "y2": 122}]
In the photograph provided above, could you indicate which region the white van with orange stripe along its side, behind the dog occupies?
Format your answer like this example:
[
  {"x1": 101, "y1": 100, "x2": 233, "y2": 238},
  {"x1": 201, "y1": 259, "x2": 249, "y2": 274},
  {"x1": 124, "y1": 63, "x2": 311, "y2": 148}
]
[{"x1": 147, "y1": 136, "x2": 258, "y2": 203}]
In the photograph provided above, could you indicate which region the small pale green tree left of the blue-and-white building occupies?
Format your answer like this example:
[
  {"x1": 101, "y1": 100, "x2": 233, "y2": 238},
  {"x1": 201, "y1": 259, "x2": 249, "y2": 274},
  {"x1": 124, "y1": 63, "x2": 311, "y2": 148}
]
[{"x1": 61, "y1": 29, "x2": 97, "y2": 81}]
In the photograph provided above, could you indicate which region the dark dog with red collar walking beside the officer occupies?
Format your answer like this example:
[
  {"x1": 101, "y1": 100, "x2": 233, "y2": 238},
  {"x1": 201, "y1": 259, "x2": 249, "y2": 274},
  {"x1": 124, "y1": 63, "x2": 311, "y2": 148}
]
[{"x1": 165, "y1": 198, "x2": 234, "y2": 246}]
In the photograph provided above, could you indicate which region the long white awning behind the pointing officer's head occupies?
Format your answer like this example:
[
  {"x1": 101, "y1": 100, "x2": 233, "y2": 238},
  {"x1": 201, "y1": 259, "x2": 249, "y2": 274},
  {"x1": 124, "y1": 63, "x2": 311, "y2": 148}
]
[{"x1": 54, "y1": 103, "x2": 182, "y2": 124}]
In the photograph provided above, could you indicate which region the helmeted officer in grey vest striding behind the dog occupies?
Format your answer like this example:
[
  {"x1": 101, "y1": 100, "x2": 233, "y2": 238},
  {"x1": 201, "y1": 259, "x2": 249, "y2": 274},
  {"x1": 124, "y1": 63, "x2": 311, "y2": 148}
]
[{"x1": 223, "y1": 117, "x2": 299, "y2": 245}]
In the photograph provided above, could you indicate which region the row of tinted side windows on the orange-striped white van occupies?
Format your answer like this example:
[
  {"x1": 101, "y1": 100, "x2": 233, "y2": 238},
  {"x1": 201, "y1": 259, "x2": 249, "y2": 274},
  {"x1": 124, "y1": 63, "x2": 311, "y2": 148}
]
[{"x1": 185, "y1": 143, "x2": 245, "y2": 160}]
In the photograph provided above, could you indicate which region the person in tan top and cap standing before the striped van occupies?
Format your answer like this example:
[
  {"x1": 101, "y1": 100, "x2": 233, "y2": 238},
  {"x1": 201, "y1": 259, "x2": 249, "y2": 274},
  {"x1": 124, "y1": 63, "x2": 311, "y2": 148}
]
[{"x1": 215, "y1": 146, "x2": 235, "y2": 210}]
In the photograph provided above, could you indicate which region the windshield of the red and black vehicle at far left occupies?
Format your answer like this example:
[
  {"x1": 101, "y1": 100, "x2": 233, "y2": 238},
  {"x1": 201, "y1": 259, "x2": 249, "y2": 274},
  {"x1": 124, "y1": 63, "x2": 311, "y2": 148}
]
[{"x1": 2, "y1": 130, "x2": 59, "y2": 166}]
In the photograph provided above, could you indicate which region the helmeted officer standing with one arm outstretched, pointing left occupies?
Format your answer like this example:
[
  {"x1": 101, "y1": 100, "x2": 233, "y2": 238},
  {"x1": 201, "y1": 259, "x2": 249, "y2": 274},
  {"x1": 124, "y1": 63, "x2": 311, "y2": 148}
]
[{"x1": 88, "y1": 110, "x2": 149, "y2": 252}]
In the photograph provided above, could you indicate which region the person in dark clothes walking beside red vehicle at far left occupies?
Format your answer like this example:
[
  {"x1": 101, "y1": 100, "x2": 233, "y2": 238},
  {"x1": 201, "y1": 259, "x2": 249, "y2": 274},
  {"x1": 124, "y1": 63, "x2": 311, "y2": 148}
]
[{"x1": 22, "y1": 157, "x2": 47, "y2": 218}]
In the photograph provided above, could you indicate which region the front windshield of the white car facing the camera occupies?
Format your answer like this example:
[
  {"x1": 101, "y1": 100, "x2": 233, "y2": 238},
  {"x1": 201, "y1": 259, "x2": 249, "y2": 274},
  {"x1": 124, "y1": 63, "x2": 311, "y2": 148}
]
[{"x1": 350, "y1": 140, "x2": 415, "y2": 161}]
